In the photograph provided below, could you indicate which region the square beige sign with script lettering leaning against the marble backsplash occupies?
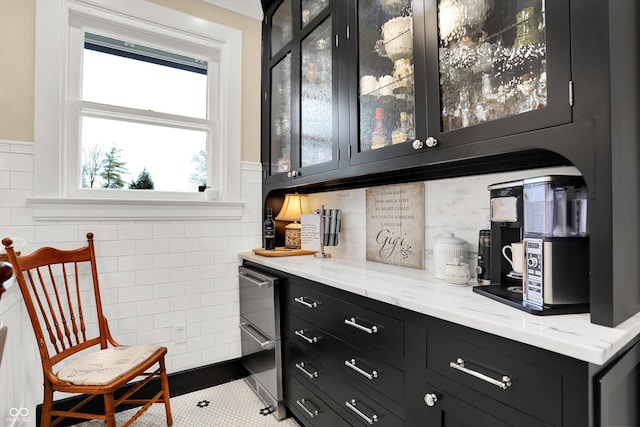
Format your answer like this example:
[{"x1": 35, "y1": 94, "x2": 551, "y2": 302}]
[{"x1": 366, "y1": 183, "x2": 425, "y2": 269}]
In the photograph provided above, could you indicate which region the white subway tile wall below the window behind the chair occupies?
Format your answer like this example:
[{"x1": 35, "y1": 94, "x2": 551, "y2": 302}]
[{"x1": 0, "y1": 141, "x2": 262, "y2": 414}]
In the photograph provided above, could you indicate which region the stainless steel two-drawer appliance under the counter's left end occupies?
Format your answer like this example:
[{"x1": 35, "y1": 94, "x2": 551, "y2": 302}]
[{"x1": 238, "y1": 266, "x2": 286, "y2": 420}]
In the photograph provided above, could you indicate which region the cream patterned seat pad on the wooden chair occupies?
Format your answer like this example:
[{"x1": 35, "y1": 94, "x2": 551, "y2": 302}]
[{"x1": 58, "y1": 345, "x2": 161, "y2": 385}]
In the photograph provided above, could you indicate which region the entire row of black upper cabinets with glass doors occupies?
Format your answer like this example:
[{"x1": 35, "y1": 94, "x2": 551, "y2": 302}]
[{"x1": 262, "y1": 0, "x2": 573, "y2": 183}]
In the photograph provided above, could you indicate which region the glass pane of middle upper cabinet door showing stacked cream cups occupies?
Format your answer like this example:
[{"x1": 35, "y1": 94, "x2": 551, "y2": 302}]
[{"x1": 356, "y1": 0, "x2": 416, "y2": 153}]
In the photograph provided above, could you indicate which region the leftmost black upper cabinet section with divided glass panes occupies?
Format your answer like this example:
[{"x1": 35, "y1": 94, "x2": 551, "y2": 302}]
[{"x1": 262, "y1": 0, "x2": 342, "y2": 186}]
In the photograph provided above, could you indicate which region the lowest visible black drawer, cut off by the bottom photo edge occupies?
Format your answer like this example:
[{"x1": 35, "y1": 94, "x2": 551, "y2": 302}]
[{"x1": 288, "y1": 377, "x2": 349, "y2": 427}]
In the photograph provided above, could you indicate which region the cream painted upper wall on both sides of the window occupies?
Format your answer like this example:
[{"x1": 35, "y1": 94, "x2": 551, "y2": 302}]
[{"x1": 0, "y1": 0, "x2": 261, "y2": 162}]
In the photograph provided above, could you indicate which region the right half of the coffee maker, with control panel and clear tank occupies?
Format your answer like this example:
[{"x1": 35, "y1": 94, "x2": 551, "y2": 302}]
[{"x1": 523, "y1": 175, "x2": 589, "y2": 307}]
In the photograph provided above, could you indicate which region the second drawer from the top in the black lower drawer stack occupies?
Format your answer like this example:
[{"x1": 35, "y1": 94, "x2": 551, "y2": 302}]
[{"x1": 288, "y1": 315, "x2": 404, "y2": 404}]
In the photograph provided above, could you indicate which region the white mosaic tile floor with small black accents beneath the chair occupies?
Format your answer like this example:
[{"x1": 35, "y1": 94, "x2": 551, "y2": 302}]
[{"x1": 76, "y1": 380, "x2": 299, "y2": 427}]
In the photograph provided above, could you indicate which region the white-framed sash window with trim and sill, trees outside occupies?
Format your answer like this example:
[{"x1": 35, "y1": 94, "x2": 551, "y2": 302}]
[{"x1": 32, "y1": 0, "x2": 242, "y2": 219}]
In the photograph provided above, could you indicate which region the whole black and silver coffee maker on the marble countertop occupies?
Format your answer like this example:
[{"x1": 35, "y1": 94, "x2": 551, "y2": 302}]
[{"x1": 473, "y1": 175, "x2": 589, "y2": 315}]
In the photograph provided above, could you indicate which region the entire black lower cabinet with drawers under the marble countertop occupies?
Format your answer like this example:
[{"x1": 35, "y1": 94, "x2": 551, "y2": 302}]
[{"x1": 245, "y1": 261, "x2": 640, "y2": 427}]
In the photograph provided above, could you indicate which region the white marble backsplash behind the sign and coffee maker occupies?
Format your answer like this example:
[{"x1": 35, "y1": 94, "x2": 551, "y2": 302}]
[{"x1": 309, "y1": 167, "x2": 580, "y2": 277}]
